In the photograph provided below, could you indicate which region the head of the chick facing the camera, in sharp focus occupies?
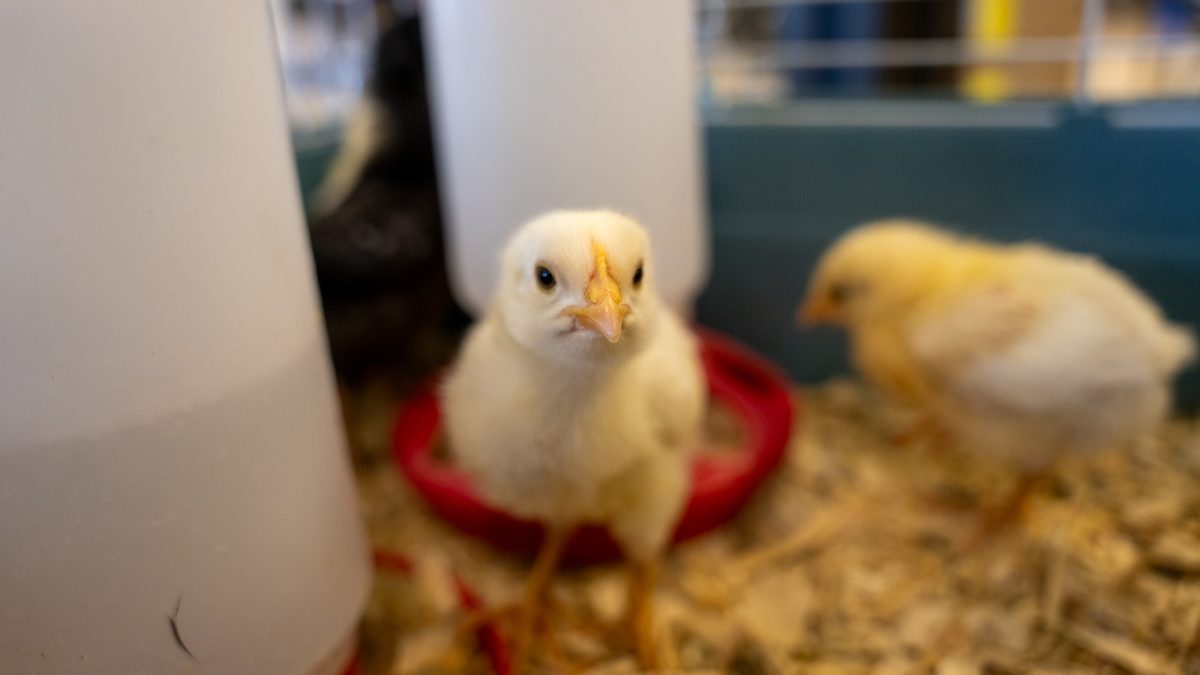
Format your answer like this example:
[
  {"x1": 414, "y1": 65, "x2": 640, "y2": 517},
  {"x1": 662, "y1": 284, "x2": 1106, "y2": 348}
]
[{"x1": 497, "y1": 211, "x2": 661, "y2": 366}]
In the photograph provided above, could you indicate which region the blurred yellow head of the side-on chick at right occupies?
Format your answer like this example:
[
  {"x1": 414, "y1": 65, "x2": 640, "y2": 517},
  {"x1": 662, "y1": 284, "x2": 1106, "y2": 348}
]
[{"x1": 800, "y1": 220, "x2": 962, "y2": 325}]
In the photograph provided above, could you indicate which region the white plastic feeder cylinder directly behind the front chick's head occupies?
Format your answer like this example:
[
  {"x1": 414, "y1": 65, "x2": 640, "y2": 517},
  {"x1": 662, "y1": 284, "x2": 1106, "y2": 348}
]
[{"x1": 424, "y1": 0, "x2": 708, "y2": 313}]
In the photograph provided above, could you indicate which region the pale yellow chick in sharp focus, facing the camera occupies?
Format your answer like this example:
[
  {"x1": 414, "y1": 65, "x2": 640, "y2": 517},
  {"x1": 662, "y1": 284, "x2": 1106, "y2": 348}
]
[{"x1": 443, "y1": 211, "x2": 707, "y2": 664}]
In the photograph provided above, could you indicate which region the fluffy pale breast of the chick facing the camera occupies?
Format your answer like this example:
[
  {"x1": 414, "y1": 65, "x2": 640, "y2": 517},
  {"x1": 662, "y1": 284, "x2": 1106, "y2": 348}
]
[{"x1": 443, "y1": 312, "x2": 702, "y2": 524}]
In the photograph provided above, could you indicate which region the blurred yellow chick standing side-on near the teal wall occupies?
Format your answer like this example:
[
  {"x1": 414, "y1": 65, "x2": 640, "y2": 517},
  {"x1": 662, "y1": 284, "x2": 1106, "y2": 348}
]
[{"x1": 802, "y1": 220, "x2": 1194, "y2": 526}]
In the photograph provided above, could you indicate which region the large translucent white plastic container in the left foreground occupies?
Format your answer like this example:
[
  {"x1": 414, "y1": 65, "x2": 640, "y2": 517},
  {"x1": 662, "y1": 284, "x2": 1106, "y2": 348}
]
[{"x1": 0, "y1": 0, "x2": 370, "y2": 675}]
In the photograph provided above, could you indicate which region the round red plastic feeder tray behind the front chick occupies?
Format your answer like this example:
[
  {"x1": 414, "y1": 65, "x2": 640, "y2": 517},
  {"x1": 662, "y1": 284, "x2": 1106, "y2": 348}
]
[{"x1": 392, "y1": 330, "x2": 792, "y2": 563}]
